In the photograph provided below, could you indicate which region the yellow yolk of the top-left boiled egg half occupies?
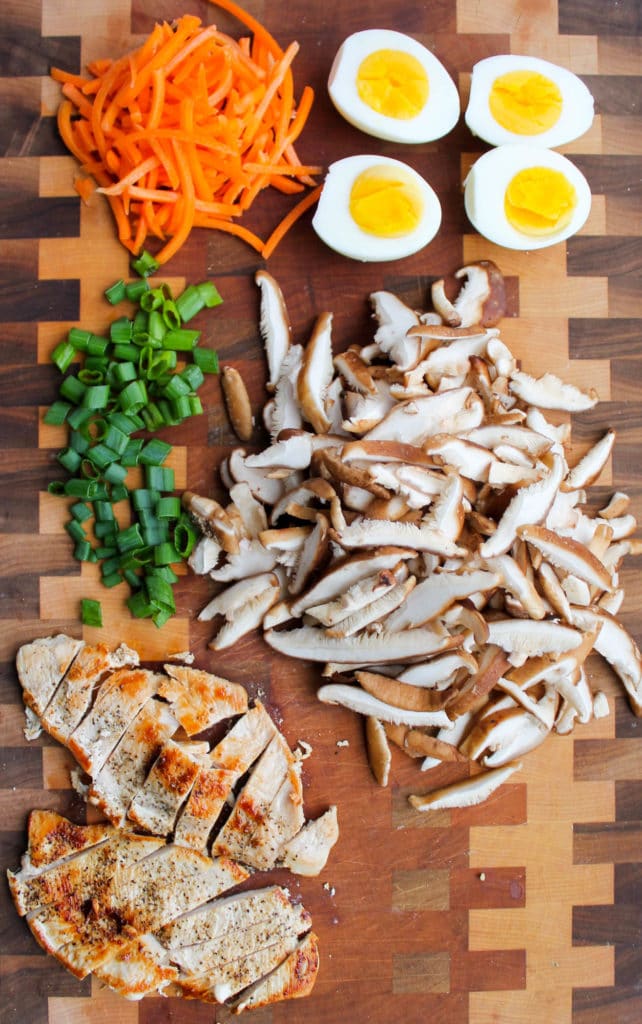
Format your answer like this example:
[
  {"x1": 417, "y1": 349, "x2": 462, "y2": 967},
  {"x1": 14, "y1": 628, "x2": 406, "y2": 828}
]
[{"x1": 356, "y1": 50, "x2": 429, "y2": 121}]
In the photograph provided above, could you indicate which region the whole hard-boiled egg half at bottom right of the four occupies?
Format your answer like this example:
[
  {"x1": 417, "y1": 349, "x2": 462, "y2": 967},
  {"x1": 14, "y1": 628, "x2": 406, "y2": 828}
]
[{"x1": 464, "y1": 145, "x2": 591, "y2": 249}]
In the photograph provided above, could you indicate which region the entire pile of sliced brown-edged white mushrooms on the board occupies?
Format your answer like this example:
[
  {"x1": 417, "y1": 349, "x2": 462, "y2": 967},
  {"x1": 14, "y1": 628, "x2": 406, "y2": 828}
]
[{"x1": 183, "y1": 261, "x2": 642, "y2": 811}]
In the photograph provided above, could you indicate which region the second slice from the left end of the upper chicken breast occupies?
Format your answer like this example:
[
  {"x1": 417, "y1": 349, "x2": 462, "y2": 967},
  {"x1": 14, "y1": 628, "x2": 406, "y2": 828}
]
[{"x1": 41, "y1": 643, "x2": 138, "y2": 744}]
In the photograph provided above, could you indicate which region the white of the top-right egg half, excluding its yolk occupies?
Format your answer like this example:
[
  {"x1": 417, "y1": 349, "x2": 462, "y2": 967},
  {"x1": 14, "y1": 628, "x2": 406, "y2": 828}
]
[{"x1": 464, "y1": 53, "x2": 594, "y2": 146}]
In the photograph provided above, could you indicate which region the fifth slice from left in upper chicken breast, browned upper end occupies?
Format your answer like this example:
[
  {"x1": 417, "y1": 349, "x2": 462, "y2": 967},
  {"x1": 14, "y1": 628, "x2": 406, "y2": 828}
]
[{"x1": 127, "y1": 739, "x2": 201, "y2": 836}]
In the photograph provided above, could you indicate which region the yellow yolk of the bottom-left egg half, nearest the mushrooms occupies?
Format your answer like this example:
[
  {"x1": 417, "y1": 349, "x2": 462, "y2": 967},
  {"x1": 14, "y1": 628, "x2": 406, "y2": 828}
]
[{"x1": 350, "y1": 165, "x2": 424, "y2": 239}]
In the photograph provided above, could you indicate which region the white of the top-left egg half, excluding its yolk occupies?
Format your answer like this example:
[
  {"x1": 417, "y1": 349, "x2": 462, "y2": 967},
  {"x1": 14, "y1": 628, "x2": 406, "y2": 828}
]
[{"x1": 328, "y1": 29, "x2": 461, "y2": 143}]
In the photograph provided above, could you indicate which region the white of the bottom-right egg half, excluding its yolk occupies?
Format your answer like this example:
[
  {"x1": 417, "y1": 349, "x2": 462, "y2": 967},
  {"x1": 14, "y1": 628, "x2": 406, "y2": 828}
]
[{"x1": 464, "y1": 145, "x2": 591, "y2": 250}]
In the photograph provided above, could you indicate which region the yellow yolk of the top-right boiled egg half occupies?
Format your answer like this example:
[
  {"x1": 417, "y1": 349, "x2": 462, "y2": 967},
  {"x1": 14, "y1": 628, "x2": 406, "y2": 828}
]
[{"x1": 488, "y1": 71, "x2": 562, "y2": 135}]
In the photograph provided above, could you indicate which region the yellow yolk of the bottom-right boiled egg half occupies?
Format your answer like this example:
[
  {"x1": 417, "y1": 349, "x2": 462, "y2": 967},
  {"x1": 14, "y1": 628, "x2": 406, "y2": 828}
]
[{"x1": 504, "y1": 167, "x2": 577, "y2": 234}]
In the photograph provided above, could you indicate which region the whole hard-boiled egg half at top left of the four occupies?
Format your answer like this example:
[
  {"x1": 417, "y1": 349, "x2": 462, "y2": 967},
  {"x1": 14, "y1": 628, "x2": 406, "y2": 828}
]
[{"x1": 328, "y1": 29, "x2": 460, "y2": 143}]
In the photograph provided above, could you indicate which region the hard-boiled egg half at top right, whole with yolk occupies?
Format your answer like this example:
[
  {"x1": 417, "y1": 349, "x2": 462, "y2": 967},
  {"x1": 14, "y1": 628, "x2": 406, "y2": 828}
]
[{"x1": 465, "y1": 54, "x2": 593, "y2": 146}]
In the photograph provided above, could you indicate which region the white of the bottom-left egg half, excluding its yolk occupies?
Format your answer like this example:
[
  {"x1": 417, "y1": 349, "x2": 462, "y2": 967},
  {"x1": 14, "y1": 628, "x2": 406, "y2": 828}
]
[{"x1": 312, "y1": 155, "x2": 441, "y2": 263}]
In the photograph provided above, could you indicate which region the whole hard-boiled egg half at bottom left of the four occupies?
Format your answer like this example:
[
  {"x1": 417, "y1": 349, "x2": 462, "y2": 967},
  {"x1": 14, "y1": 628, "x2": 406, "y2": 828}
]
[{"x1": 312, "y1": 156, "x2": 441, "y2": 262}]
